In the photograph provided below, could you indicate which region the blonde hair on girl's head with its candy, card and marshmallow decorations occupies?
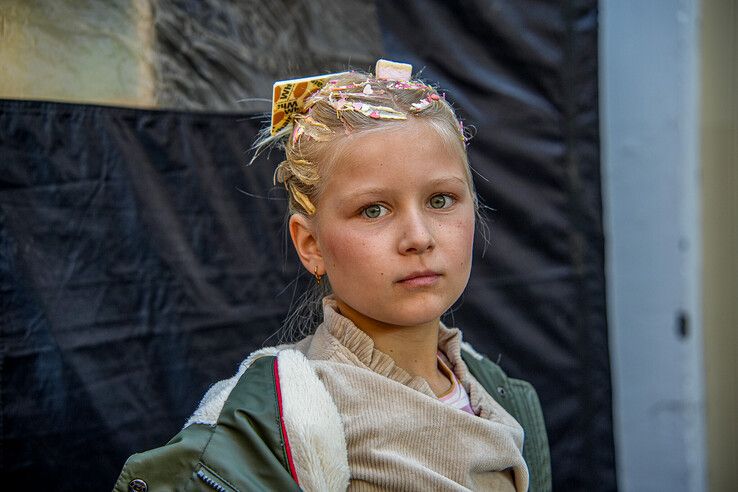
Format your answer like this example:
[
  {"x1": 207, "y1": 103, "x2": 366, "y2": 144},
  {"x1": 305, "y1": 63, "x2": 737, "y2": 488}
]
[{"x1": 254, "y1": 60, "x2": 476, "y2": 216}]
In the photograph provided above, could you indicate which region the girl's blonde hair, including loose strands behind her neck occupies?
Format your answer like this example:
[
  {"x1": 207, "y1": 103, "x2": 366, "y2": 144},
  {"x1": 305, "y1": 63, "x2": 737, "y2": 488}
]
[{"x1": 252, "y1": 71, "x2": 478, "y2": 342}]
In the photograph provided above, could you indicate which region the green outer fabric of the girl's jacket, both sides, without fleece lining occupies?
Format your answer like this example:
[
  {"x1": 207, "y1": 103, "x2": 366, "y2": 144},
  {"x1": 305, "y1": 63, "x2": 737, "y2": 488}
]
[{"x1": 114, "y1": 349, "x2": 551, "y2": 492}]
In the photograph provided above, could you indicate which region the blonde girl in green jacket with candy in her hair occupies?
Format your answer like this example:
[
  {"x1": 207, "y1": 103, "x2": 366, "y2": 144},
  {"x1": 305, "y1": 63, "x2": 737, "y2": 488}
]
[{"x1": 116, "y1": 60, "x2": 550, "y2": 491}]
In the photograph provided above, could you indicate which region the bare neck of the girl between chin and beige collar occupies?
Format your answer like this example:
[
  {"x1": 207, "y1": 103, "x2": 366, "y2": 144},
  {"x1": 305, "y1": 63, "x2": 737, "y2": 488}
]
[{"x1": 336, "y1": 299, "x2": 451, "y2": 394}]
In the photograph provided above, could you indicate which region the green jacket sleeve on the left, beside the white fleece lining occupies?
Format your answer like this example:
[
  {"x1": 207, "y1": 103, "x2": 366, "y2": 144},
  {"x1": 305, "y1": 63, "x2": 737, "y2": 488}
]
[{"x1": 114, "y1": 357, "x2": 299, "y2": 492}]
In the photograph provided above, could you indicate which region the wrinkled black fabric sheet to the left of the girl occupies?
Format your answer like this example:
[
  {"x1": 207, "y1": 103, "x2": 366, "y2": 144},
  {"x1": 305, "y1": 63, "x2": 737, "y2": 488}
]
[{"x1": 0, "y1": 101, "x2": 301, "y2": 490}]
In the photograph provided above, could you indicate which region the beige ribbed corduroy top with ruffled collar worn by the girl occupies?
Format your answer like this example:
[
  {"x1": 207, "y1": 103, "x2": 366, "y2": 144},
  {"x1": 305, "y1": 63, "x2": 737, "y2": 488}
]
[{"x1": 296, "y1": 298, "x2": 528, "y2": 492}]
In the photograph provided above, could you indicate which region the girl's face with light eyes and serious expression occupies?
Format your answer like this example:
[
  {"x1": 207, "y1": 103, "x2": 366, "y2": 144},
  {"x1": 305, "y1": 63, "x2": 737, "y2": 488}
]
[{"x1": 306, "y1": 120, "x2": 474, "y2": 326}]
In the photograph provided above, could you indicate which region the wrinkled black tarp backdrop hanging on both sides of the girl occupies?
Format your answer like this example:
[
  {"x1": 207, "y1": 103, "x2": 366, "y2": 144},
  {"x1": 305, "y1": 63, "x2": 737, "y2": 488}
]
[{"x1": 0, "y1": 1, "x2": 615, "y2": 491}]
